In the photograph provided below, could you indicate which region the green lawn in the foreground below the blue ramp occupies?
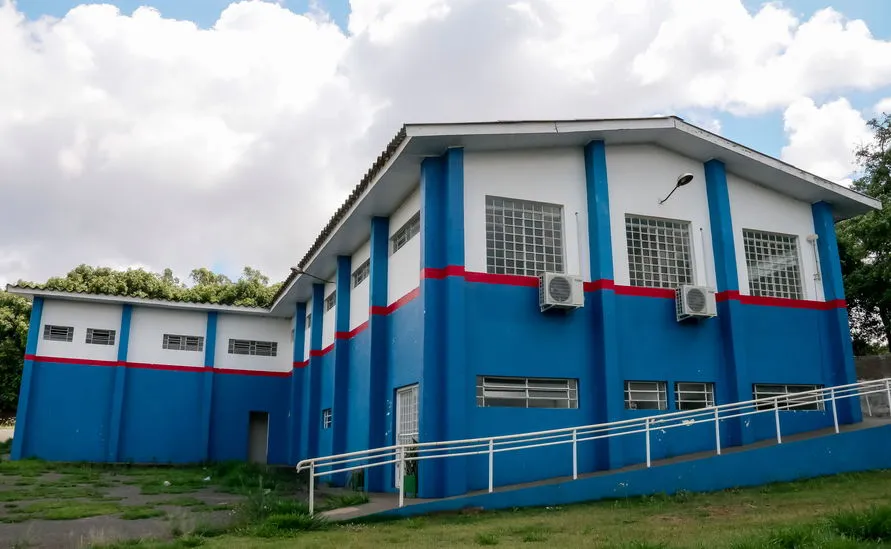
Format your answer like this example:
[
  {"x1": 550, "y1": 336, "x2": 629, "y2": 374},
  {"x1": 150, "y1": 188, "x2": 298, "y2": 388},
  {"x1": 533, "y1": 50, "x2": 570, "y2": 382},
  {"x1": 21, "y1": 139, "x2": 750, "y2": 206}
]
[{"x1": 96, "y1": 471, "x2": 891, "y2": 549}]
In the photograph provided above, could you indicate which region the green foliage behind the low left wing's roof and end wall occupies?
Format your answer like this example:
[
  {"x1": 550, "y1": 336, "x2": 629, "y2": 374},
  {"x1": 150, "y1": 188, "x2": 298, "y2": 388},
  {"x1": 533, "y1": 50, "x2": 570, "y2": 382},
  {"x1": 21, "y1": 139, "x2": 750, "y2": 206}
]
[{"x1": 0, "y1": 265, "x2": 281, "y2": 414}]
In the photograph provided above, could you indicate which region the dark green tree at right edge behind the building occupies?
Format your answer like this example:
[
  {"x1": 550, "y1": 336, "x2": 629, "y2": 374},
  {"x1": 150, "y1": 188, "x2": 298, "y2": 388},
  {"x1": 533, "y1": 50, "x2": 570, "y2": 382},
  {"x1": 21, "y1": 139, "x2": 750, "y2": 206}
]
[{"x1": 837, "y1": 114, "x2": 891, "y2": 354}]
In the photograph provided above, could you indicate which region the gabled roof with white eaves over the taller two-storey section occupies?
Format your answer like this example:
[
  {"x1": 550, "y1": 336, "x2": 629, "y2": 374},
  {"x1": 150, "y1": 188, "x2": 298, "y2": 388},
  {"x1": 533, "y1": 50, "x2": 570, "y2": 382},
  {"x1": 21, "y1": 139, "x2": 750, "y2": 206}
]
[{"x1": 272, "y1": 116, "x2": 881, "y2": 310}]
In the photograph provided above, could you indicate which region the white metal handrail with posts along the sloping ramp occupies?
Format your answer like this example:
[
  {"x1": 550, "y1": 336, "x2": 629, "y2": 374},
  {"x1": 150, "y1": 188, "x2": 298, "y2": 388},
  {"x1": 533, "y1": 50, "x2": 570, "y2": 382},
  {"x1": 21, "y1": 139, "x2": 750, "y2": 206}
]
[{"x1": 297, "y1": 378, "x2": 891, "y2": 513}]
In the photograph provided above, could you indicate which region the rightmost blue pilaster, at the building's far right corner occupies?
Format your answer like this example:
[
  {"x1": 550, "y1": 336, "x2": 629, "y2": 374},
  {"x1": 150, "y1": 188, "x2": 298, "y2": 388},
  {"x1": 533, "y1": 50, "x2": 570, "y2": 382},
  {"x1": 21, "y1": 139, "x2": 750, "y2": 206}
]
[{"x1": 811, "y1": 202, "x2": 863, "y2": 423}]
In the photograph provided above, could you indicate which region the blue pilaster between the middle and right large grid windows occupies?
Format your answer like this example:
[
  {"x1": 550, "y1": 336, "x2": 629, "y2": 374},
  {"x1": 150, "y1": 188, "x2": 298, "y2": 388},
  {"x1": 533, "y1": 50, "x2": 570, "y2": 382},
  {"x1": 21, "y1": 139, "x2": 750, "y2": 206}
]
[{"x1": 704, "y1": 159, "x2": 754, "y2": 445}]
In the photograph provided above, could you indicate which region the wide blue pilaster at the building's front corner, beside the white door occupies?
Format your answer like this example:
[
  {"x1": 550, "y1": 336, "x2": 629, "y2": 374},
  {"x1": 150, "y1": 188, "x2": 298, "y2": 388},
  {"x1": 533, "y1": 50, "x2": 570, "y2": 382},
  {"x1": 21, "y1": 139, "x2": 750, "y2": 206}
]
[{"x1": 418, "y1": 149, "x2": 475, "y2": 497}]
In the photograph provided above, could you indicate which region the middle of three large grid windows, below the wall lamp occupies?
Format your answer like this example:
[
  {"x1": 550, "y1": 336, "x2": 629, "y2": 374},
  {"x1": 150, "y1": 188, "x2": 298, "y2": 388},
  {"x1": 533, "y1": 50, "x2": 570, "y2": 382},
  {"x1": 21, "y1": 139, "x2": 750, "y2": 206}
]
[{"x1": 625, "y1": 215, "x2": 693, "y2": 288}]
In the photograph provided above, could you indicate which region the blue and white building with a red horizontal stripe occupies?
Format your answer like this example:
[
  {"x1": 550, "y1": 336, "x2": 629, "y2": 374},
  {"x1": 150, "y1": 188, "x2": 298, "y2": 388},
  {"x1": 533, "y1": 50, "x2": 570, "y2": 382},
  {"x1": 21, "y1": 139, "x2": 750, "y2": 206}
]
[{"x1": 9, "y1": 117, "x2": 880, "y2": 496}]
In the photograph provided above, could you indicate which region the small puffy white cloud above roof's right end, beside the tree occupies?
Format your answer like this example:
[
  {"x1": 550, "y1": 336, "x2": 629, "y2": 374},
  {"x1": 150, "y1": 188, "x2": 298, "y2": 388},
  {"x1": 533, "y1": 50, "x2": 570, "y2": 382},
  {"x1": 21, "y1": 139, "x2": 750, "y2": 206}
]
[{"x1": 782, "y1": 98, "x2": 871, "y2": 185}]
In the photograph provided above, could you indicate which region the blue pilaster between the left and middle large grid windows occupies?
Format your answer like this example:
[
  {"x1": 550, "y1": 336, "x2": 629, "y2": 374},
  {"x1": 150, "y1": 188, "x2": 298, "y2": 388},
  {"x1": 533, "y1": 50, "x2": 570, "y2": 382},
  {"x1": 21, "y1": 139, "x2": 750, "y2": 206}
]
[{"x1": 579, "y1": 141, "x2": 625, "y2": 469}]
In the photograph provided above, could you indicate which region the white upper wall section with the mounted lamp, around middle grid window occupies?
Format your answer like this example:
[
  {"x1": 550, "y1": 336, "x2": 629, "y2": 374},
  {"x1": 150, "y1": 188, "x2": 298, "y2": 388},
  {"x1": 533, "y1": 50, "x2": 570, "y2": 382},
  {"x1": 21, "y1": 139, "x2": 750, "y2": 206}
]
[{"x1": 606, "y1": 145, "x2": 716, "y2": 287}]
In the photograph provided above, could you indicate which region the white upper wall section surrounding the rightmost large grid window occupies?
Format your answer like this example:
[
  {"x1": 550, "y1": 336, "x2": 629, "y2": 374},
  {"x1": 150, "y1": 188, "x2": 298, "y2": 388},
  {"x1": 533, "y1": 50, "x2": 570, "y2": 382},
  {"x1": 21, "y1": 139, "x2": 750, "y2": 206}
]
[{"x1": 727, "y1": 173, "x2": 823, "y2": 301}]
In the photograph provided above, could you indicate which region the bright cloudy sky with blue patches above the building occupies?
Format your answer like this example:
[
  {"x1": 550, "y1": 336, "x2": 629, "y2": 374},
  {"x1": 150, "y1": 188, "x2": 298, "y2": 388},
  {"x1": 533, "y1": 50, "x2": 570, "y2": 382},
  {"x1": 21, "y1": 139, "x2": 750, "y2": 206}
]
[{"x1": 0, "y1": 0, "x2": 891, "y2": 287}]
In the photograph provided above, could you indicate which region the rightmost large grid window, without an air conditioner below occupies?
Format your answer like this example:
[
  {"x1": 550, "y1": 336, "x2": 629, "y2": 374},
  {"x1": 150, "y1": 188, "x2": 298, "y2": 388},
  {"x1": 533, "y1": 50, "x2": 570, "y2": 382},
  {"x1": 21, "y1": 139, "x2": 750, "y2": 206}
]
[{"x1": 743, "y1": 229, "x2": 801, "y2": 299}]
